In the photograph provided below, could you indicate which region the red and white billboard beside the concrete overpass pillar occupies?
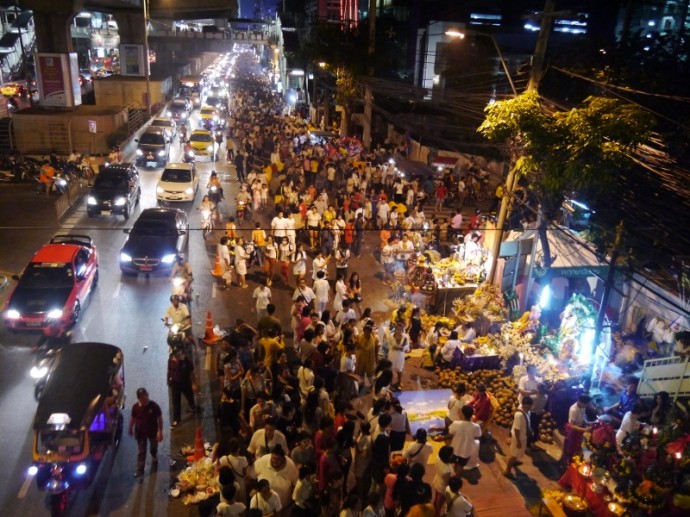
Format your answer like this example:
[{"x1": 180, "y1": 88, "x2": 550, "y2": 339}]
[{"x1": 35, "y1": 52, "x2": 81, "y2": 108}]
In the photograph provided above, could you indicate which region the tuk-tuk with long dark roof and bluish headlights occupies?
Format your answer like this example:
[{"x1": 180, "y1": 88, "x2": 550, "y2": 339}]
[{"x1": 30, "y1": 343, "x2": 125, "y2": 505}]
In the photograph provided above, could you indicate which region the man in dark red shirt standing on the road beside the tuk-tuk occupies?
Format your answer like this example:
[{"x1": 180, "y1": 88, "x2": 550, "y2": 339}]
[{"x1": 129, "y1": 388, "x2": 163, "y2": 477}]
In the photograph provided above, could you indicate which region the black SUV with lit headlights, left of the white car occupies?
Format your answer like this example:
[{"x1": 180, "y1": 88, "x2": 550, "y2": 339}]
[{"x1": 86, "y1": 163, "x2": 141, "y2": 219}]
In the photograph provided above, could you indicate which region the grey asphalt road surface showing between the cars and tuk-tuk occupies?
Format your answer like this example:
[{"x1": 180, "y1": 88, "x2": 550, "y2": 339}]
[{"x1": 0, "y1": 107, "x2": 251, "y2": 516}]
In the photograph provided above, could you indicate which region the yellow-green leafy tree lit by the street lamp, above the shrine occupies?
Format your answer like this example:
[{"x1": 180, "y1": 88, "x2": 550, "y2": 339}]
[{"x1": 478, "y1": 91, "x2": 655, "y2": 268}]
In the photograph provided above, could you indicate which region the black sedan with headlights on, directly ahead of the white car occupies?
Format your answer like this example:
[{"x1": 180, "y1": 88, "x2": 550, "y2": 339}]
[{"x1": 120, "y1": 208, "x2": 189, "y2": 273}]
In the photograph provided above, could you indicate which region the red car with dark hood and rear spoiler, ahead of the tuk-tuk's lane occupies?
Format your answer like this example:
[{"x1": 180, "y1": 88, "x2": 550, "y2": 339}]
[{"x1": 3, "y1": 235, "x2": 98, "y2": 337}]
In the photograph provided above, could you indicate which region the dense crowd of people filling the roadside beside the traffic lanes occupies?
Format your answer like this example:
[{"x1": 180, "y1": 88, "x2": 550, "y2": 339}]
[{"x1": 161, "y1": 56, "x2": 490, "y2": 517}]
